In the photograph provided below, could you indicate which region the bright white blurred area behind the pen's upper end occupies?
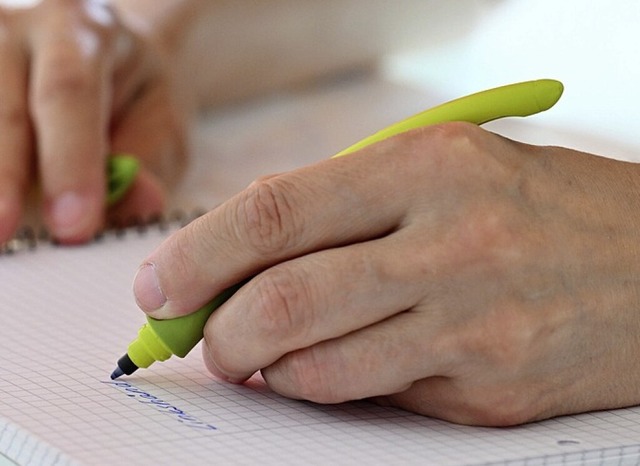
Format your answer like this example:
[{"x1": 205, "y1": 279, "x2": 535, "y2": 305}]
[{"x1": 385, "y1": 0, "x2": 640, "y2": 160}]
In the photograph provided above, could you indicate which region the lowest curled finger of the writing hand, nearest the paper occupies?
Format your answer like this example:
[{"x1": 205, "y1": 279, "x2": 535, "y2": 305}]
[{"x1": 262, "y1": 311, "x2": 452, "y2": 403}]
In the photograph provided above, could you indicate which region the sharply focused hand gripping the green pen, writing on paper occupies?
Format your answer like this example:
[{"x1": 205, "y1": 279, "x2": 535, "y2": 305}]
[{"x1": 134, "y1": 123, "x2": 640, "y2": 425}]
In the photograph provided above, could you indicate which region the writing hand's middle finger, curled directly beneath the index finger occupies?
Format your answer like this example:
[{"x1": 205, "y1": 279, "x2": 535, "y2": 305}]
[{"x1": 205, "y1": 236, "x2": 425, "y2": 381}]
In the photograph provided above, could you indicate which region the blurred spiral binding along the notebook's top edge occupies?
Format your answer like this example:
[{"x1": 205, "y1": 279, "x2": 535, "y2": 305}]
[{"x1": 0, "y1": 209, "x2": 205, "y2": 256}]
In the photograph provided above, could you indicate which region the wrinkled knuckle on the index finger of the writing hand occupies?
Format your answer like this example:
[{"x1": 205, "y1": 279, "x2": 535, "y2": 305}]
[{"x1": 238, "y1": 177, "x2": 302, "y2": 257}]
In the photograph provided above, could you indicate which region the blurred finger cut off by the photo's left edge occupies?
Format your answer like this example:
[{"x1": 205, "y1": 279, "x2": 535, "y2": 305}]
[{"x1": 0, "y1": 27, "x2": 32, "y2": 243}]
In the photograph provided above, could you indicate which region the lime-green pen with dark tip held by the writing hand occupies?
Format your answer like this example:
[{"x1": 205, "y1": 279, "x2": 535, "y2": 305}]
[{"x1": 111, "y1": 79, "x2": 563, "y2": 379}]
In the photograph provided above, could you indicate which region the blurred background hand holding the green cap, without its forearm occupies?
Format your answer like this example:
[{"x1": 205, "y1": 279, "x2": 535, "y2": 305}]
[{"x1": 0, "y1": 0, "x2": 185, "y2": 243}]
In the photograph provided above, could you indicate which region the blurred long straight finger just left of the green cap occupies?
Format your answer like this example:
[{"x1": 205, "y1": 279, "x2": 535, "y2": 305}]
[{"x1": 30, "y1": 9, "x2": 111, "y2": 242}]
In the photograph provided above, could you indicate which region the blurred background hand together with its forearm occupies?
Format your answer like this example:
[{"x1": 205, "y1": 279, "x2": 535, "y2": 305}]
[{"x1": 0, "y1": 0, "x2": 432, "y2": 243}]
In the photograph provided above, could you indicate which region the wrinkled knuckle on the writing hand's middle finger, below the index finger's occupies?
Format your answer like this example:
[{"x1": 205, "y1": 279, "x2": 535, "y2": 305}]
[{"x1": 256, "y1": 267, "x2": 313, "y2": 341}]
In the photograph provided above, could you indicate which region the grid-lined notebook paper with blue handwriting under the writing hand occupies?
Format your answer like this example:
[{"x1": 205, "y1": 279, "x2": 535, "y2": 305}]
[{"x1": 0, "y1": 224, "x2": 640, "y2": 465}]
